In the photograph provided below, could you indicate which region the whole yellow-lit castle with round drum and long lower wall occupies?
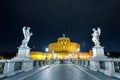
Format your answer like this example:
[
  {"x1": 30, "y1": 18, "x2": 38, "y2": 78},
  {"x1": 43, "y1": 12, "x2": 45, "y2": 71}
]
[{"x1": 30, "y1": 34, "x2": 92, "y2": 60}]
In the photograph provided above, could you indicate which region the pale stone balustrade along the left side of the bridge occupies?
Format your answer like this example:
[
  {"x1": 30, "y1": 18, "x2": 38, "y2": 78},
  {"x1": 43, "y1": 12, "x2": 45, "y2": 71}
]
[{"x1": 0, "y1": 60, "x2": 49, "y2": 78}]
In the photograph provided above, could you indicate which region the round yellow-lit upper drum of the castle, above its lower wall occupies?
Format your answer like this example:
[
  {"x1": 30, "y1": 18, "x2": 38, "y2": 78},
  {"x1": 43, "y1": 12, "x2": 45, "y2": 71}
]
[{"x1": 48, "y1": 37, "x2": 80, "y2": 53}]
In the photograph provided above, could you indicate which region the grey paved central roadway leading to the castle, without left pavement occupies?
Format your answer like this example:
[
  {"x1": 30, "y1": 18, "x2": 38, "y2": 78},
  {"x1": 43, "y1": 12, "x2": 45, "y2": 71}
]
[{"x1": 24, "y1": 64, "x2": 118, "y2": 80}]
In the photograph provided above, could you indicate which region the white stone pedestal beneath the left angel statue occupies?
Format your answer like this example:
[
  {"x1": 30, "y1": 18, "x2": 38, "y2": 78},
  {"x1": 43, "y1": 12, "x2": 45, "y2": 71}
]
[{"x1": 12, "y1": 47, "x2": 33, "y2": 71}]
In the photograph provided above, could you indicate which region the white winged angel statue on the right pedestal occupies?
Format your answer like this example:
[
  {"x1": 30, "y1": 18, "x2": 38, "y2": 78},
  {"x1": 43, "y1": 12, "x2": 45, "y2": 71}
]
[{"x1": 92, "y1": 27, "x2": 101, "y2": 47}]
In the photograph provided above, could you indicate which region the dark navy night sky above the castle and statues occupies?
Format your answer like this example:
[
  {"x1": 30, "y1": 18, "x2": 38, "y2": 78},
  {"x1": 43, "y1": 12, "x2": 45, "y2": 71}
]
[{"x1": 0, "y1": 0, "x2": 120, "y2": 52}]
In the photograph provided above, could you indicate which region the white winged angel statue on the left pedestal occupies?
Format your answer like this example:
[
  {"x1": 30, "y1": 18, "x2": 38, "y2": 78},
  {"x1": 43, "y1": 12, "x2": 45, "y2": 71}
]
[{"x1": 20, "y1": 26, "x2": 33, "y2": 47}]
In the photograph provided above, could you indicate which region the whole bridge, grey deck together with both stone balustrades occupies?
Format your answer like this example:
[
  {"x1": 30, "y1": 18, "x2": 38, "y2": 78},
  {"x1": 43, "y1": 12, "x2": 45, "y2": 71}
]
[{"x1": 0, "y1": 60, "x2": 120, "y2": 80}]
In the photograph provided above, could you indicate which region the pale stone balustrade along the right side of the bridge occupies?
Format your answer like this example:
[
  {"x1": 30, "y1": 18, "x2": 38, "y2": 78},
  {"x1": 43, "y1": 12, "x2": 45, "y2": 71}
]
[{"x1": 77, "y1": 58, "x2": 120, "y2": 78}]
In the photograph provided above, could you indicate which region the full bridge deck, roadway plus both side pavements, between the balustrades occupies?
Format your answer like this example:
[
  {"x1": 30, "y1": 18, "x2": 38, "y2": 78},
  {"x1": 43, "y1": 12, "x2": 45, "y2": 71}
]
[{"x1": 2, "y1": 64, "x2": 120, "y2": 80}]
